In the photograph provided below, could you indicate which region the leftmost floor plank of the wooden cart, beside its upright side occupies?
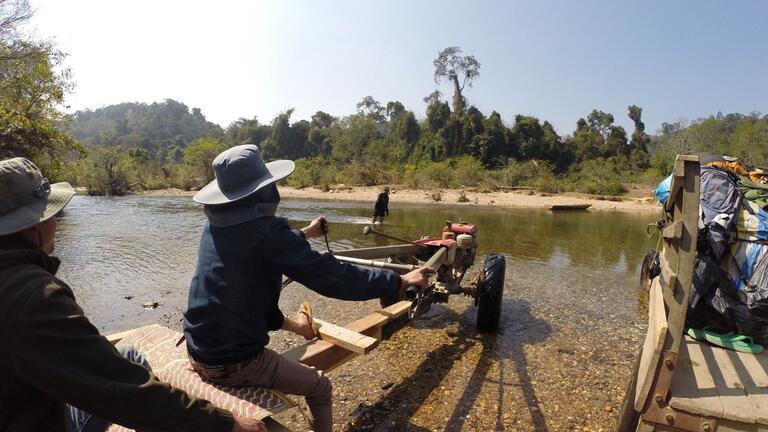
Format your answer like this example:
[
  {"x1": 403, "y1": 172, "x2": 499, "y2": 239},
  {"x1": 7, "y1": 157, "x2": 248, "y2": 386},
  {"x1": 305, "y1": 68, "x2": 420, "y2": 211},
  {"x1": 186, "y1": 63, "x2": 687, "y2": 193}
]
[{"x1": 669, "y1": 338, "x2": 723, "y2": 418}]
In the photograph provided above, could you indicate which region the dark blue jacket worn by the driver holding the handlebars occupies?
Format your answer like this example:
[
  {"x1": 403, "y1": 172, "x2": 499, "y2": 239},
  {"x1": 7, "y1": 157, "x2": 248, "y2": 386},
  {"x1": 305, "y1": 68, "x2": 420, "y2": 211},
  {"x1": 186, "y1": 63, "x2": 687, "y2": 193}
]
[{"x1": 184, "y1": 216, "x2": 400, "y2": 365}]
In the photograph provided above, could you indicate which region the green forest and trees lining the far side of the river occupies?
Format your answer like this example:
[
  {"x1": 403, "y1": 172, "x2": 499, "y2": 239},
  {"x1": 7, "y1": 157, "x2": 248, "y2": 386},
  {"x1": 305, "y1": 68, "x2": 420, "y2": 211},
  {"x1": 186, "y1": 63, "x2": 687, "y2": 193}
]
[{"x1": 0, "y1": 0, "x2": 768, "y2": 195}]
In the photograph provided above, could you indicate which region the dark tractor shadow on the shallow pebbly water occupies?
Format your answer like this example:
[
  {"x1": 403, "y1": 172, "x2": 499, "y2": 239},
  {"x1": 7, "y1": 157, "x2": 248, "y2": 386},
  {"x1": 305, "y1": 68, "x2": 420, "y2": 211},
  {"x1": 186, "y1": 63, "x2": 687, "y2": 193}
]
[{"x1": 347, "y1": 300, "x2": 552, "y2": 432}]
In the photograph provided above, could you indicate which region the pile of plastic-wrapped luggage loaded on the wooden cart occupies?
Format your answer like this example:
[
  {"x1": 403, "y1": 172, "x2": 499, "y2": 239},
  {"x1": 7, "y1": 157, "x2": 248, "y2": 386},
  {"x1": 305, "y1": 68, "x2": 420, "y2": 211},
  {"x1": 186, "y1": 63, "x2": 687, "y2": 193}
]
[{"x1": 654, "y1": 157, "x2": 768, "y2": 345}]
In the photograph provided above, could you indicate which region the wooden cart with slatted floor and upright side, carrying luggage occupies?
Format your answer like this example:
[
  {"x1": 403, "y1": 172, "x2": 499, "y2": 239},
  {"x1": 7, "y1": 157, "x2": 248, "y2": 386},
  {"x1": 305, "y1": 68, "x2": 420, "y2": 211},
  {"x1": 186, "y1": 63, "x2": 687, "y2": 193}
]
[{"x1": 616, "y1": 155, "x2": 768, "y2": 432}]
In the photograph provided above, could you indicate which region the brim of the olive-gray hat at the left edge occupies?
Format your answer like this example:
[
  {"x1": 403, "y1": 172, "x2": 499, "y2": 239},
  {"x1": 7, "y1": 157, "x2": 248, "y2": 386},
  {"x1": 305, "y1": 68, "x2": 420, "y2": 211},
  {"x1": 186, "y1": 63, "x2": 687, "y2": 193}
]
[{"x1": 0, "y1": 182, "x2": 75, "y2": 236}]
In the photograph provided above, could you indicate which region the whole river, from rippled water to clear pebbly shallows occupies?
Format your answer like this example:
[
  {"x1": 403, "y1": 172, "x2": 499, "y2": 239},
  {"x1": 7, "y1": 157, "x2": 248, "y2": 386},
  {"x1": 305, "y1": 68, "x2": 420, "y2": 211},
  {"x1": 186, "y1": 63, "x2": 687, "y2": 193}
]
[{"x1": 57, "y1": 196, "x2": 657, "y2": 432}]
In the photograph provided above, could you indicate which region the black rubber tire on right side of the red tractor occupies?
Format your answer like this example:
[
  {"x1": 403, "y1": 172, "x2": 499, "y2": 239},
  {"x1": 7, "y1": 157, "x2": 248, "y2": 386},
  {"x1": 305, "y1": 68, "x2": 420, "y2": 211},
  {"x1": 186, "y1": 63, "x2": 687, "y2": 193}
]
[{"x1": 477, "y1": 254, "x2": 507, "y2": 333}]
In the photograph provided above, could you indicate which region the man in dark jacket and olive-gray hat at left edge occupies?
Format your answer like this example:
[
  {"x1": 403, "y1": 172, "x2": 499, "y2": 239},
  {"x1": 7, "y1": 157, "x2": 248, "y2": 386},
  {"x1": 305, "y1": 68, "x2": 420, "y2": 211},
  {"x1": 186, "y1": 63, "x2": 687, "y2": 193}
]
[{"x1": 0, "y1": 158, "x2": 265, "y2": 432}]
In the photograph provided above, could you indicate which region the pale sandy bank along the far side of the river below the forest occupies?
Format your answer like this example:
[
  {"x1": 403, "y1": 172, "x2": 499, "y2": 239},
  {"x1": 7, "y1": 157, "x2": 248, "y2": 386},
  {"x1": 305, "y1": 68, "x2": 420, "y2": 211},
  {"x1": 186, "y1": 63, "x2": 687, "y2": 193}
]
[{"x1": 140, "y1": 186, "x2": 659, "y2": 212}]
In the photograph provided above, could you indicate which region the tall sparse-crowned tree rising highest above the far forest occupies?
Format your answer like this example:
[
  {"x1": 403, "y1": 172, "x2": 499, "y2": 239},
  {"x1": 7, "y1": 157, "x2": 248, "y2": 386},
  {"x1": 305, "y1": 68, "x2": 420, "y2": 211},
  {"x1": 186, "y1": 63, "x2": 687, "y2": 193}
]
[{"x1": 433, "y1": 46, "x2": 480, "y2": 115}]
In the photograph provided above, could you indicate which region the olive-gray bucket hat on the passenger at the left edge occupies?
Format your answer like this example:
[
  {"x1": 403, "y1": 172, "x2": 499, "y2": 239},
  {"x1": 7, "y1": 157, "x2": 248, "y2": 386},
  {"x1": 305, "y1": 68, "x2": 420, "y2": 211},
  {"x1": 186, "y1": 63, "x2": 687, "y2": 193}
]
[{"x1": 0, "y1": 158, "x2": 75, "y2": 236}]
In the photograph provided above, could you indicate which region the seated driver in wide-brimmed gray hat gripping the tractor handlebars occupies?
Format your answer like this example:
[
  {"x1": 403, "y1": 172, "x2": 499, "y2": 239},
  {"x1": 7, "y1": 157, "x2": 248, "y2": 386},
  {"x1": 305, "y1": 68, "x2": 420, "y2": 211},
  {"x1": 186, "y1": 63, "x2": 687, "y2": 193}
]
[{"x1": 184, "y1": 144, "x2": 430, "y2": 432}]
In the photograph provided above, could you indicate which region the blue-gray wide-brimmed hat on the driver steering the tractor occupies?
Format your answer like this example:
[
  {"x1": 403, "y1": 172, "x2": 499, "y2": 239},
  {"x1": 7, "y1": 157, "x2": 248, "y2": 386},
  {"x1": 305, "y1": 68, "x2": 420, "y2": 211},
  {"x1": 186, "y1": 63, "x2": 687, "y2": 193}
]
[{"x1": 192, "y1": 144, "x2": 296, "y2": 205}]
